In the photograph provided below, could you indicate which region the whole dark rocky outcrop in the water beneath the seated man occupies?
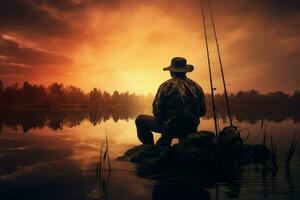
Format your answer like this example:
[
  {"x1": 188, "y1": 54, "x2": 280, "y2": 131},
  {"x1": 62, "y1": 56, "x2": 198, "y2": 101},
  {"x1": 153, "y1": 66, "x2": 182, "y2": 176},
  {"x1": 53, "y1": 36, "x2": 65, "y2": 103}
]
[{"x1": 118, "y1": 127, "x2": 270, "y2": 171}]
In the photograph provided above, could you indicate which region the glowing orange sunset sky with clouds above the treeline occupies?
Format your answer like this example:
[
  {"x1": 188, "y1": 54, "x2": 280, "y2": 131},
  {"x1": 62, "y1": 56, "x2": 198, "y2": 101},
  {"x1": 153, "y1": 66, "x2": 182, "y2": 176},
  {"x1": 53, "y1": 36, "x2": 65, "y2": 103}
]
[{"x1": 0, "y1": 0, "x2": 300, "y2": 94}]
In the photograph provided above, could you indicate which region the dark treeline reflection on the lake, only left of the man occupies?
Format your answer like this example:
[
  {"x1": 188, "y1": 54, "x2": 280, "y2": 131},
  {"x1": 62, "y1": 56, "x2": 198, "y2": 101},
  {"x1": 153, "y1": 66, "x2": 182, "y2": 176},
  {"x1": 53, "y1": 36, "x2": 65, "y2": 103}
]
[{"x1": 0, "y1": 108, "x2": 144, "y2": 133}]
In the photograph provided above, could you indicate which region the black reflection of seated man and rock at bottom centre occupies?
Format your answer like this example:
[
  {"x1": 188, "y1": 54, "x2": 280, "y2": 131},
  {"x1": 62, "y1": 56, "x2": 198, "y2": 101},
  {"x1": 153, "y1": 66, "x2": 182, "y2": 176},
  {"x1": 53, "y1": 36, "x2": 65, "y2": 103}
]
[{"x1": 136, "y1": 166, "x2": 217, "y2": 200}]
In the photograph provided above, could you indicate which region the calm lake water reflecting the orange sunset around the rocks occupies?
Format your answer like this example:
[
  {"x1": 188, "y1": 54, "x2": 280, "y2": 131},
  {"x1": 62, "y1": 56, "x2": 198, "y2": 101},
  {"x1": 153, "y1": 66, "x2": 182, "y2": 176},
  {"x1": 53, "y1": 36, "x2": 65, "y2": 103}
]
[{"x1": 0, "y1": 108, "x2": 300, "y2": 200}]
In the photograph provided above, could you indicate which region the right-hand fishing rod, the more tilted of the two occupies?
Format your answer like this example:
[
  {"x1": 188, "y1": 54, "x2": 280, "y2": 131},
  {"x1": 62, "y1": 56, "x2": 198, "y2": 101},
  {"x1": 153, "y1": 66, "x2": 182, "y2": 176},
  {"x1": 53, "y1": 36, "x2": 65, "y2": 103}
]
[{"x1": 207, "y1": 0, "x2": 232, "y2": 126}]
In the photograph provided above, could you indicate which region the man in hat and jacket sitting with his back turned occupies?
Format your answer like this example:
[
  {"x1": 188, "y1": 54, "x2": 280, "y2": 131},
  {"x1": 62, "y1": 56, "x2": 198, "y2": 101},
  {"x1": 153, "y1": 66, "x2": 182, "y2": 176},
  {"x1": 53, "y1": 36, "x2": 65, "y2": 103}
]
[{"x1": 135, "y1": 57, "x2": 206, "y2": 146}]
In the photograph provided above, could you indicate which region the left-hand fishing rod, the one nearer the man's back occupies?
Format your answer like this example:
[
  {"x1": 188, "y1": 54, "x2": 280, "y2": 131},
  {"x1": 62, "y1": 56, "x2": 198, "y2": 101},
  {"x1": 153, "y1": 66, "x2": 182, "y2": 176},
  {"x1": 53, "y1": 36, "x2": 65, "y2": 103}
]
[{"x1": 200, "y1": 0, "x2": 219, "y2": 136}]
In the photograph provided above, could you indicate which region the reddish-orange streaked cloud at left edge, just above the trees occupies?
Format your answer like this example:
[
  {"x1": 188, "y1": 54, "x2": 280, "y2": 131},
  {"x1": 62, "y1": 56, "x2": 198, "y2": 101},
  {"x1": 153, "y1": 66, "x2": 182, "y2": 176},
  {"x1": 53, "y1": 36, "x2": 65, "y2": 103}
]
[{"x1": 0, "y1": 36, "x2": 72, "y2": 84}]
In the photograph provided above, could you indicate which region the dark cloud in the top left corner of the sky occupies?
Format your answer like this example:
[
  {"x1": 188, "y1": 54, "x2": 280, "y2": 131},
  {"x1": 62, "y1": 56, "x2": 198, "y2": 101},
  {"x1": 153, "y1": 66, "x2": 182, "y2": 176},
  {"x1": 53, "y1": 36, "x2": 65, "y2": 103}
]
[{"x1": 0, "y1": 0, "x2": 76, "y2": 37}]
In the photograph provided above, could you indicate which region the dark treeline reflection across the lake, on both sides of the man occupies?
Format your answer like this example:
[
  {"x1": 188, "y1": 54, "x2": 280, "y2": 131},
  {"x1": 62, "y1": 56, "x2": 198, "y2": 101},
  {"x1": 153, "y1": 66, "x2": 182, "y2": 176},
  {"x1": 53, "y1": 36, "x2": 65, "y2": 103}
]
[{"x1": 0, "y1": 108, "x2": 300, "y2": 133}]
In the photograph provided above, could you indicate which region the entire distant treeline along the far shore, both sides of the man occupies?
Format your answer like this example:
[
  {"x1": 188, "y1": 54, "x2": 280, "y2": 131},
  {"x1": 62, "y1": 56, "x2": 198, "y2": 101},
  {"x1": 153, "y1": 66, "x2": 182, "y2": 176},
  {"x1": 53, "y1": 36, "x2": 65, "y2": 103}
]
[{"x1": 0, "y1": 80, "x2": 300, "y2": 108}]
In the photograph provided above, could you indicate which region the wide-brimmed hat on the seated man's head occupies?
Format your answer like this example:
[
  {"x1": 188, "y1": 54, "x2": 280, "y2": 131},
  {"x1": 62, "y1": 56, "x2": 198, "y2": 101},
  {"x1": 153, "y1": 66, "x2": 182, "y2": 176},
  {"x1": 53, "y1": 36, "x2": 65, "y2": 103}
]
[{"x1": 163, "y1": 57, "x2": 194, "y2": 72}]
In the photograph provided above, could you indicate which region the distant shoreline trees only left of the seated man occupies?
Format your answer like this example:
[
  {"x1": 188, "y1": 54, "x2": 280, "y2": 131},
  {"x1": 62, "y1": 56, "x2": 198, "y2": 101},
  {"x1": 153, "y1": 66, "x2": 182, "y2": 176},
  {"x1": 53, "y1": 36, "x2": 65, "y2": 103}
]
[{"x1": 0, "y1": 80, "x2": 149, "y2": 107}]
